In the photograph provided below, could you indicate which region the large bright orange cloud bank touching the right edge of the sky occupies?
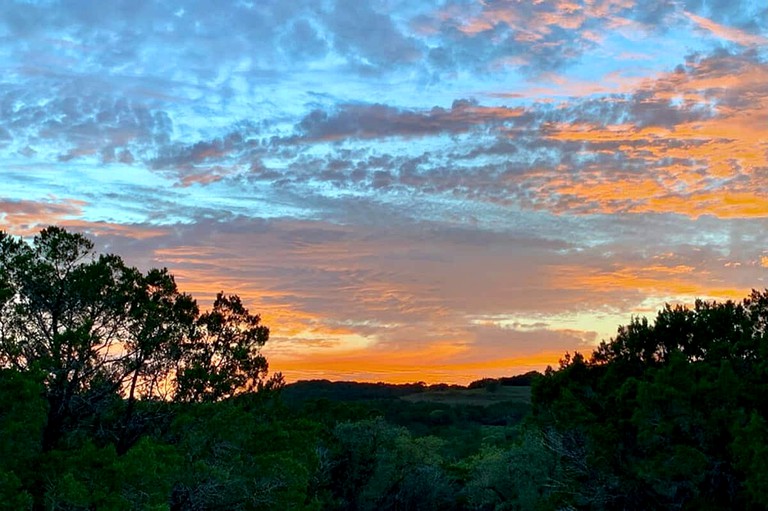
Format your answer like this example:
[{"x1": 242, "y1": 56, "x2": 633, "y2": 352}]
[{"x1": 521, "y1": 52, "x2": 768, "y2": 218}]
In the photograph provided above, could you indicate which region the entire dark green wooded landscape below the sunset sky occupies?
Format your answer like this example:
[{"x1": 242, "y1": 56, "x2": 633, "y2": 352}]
[{"x1": 0, "y1": 228, "x2": 768, "y2": 511}]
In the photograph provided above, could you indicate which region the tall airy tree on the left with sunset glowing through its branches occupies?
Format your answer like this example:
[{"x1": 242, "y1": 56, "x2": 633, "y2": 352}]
[{"x1": 0, "y1": 227, "x2": 282, "y2": 451}]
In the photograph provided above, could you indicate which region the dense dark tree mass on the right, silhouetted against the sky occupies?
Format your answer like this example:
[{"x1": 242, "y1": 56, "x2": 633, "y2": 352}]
[{"x1": 533, "y1": 291, "x2": 768, "y2": 509}]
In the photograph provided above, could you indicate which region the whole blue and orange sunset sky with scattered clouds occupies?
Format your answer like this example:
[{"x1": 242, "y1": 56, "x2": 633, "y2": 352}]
[{"x1": 0, "y1": 0, "x2": 768, "y2": 383}]
